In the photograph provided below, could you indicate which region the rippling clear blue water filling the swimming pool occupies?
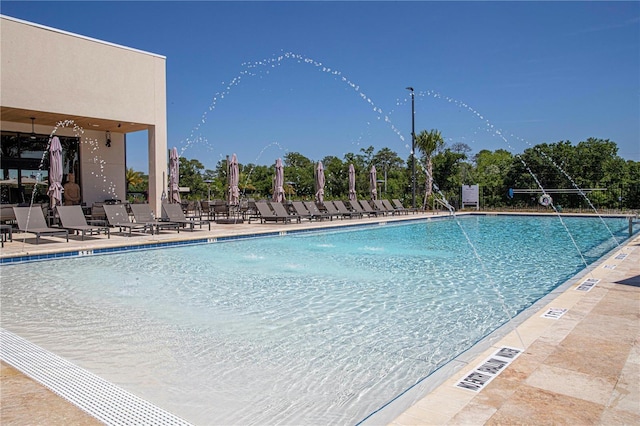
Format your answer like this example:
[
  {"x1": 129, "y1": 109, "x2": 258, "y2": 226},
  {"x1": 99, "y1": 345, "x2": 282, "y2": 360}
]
[{"x1": 0, "y1": 216, "x2": 627, "y2": 425}]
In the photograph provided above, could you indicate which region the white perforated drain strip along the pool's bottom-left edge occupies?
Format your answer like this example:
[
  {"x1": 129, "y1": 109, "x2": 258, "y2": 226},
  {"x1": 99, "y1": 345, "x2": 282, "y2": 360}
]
[{"x1": 0, "y1": 328, "x2": 189, "y2": 425}]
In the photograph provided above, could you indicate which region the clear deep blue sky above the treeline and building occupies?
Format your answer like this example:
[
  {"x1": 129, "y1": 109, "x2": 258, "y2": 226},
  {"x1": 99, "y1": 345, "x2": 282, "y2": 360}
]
[{"x1": 0, "y1": 1, "x2": 640, "y2": 172}]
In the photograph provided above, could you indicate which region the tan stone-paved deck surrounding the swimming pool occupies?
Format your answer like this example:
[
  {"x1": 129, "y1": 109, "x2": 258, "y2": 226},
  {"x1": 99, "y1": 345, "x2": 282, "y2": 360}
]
[{"x1": 0, "y1": 212, "x2": 640, "y2": 426}]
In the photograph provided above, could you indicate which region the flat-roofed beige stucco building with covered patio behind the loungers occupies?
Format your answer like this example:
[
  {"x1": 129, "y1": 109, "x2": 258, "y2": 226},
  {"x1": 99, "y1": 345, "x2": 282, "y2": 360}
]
[{"x1": 0, "y1": 15, "x2": 167, "y2": 212}]
